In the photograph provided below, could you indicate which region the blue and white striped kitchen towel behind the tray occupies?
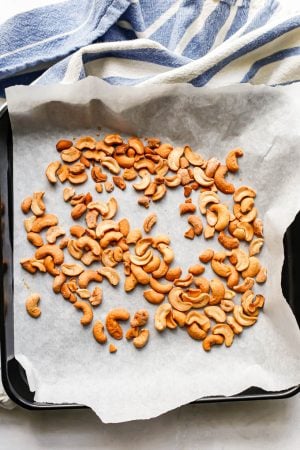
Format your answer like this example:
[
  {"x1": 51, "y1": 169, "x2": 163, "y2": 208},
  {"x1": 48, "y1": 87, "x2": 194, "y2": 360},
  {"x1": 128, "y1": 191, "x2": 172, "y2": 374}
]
[{"x1": 0, "y1": 0, "x2": 300, "y2": 96}]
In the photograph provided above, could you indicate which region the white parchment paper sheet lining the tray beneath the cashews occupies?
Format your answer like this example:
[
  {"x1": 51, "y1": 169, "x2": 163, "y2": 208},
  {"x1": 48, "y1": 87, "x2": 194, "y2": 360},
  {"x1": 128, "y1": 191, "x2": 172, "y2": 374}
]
[{"x1": 7, "y1": 77, "x2": 300, "y2": 422}]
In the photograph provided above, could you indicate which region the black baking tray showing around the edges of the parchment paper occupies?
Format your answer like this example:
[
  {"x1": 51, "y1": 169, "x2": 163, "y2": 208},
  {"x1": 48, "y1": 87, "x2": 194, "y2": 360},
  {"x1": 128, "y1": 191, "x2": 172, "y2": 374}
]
[{"x1": 0, "y1": 106, "x2": 300, "y2": 410}]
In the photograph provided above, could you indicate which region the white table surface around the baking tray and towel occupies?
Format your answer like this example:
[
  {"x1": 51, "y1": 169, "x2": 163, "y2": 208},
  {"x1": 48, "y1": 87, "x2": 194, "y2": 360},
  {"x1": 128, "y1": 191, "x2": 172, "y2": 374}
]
[{"x1": 0, "y1": 0, "x2": 300, "y2": 450}]
